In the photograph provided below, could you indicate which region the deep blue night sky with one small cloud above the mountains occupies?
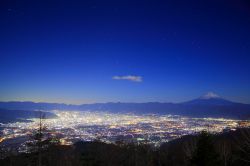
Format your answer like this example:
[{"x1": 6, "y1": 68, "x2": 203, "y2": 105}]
[{"x1": 0, "y1": 0, "x2": 250, "y2": 104}]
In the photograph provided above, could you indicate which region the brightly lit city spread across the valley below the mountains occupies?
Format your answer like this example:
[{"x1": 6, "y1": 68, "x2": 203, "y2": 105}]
[{"x1": 0, "y1": 110, "x2": 249, "y2": 149}]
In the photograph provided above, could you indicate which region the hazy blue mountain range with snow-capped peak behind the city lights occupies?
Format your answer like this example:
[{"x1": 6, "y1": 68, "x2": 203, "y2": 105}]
[{"x1": 0, "y1": 92, "x2": 250, "y2": 119}]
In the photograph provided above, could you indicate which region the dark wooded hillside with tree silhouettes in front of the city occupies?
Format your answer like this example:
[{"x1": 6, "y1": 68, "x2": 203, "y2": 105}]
[{"x1": 0, "y1": 129, "x2": 250, "y2": 166}]
